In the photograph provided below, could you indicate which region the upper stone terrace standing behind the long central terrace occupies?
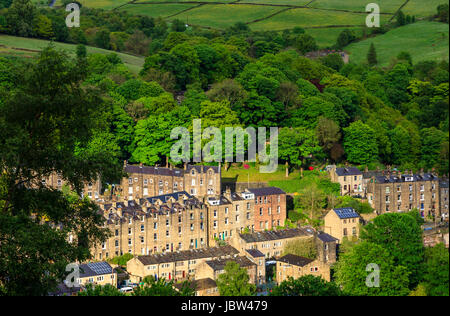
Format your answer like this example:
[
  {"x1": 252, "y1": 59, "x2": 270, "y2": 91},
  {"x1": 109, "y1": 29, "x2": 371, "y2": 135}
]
[{"x1": 118, "y1": 161, "x2": 221, "y2": 200}]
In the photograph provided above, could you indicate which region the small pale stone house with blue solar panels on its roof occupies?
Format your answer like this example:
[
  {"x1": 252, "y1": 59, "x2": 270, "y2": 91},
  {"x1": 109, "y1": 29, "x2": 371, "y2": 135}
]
[{"x1": 324, "y1": 207, "x2": 360, "y2": 243}]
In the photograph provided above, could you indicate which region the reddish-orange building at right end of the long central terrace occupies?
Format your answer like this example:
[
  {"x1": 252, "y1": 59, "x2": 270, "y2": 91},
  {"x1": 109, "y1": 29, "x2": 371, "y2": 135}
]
[{"x1": 248, "y1": 187, "x2": 287, "y2": 231}]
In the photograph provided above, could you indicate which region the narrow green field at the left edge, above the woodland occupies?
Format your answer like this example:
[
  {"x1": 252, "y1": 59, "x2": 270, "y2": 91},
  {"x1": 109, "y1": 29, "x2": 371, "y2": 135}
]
[{"x1": 0, "y1": 35, "x2": 144, "y2": 73}]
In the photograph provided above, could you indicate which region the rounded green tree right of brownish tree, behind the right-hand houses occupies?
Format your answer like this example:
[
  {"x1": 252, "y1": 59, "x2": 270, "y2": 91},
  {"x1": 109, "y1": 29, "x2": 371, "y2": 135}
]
[{"x1": 344, "y1": 121, "x2": 378, "y2": 165}]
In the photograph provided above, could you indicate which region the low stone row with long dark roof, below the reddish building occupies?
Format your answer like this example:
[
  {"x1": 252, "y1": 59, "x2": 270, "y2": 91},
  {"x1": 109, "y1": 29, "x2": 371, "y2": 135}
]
[{"x1": 231, "y1": 228, "x2": 314, "y2": 259}]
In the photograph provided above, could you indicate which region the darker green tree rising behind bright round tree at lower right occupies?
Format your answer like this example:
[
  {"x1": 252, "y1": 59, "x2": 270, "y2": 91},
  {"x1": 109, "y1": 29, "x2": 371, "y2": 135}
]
[{"x1": 360, "y1": 213, "x2": 424, "y2": 288}]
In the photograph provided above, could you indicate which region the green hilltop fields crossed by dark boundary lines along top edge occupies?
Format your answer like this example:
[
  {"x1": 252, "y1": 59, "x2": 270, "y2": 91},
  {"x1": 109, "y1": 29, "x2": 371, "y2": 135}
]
[{"x1": 36, "y1": 0, "x2": 448, "y2": 47}]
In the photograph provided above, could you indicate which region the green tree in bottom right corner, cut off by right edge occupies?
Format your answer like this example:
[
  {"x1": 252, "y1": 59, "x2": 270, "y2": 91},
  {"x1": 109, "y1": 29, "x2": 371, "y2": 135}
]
[{"x1": 424, "y1": 243, "x2": 449, "y2": 296}]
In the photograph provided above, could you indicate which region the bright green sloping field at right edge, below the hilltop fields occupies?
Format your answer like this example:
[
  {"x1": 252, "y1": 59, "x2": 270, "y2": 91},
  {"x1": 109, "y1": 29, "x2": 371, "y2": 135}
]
[{"x1": 346, "y1": 21, "x2": 449, "y2": 66}]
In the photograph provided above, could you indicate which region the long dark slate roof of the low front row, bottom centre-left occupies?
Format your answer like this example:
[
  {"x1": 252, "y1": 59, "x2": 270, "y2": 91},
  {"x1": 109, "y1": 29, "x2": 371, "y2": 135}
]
[{"x1": 137, "y1": 245, "x2": 239, "y2": 266}]
